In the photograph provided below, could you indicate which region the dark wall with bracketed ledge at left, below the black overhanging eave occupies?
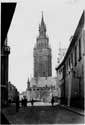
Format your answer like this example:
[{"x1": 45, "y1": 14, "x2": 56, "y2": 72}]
[{"x1": 1, "y1": 38, "x2": 10, "y2": 105}]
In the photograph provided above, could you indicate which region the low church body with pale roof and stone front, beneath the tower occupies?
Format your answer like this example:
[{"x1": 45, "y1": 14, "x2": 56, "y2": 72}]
[{"x1": 26, "y1": 77, "x2": 60, "y2": 102}]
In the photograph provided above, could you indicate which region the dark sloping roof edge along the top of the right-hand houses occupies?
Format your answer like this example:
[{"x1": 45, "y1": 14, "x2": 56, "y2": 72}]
[{"x1": 56, "y1": 10, "x2": 85, "y2": 70}]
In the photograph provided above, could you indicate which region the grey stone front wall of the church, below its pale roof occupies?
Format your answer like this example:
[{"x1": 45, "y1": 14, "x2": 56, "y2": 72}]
[{"x1": 29, "y1": 85, "x2": 58, "y2": 102}]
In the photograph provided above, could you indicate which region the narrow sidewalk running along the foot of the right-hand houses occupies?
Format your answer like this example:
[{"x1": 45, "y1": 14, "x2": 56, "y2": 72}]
[{"x1": 60, "y1": 104, "x2": 85, "y2": 116}]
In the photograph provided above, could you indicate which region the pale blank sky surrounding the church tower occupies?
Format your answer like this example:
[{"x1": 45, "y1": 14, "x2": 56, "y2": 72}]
[{"x1": 8, "y1": 0, "x2": 85, "y2": 92}]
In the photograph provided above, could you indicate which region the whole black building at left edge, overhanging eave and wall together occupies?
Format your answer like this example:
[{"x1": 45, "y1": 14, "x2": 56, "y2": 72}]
[{"x1": 0, "y1": 2, "x2": 16, "y2": 107}]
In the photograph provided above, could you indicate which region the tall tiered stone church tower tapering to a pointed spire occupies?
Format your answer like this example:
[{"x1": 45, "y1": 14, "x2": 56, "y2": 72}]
[{"x1": 33, "y1": 13, "x2": 52, "y2": 77}]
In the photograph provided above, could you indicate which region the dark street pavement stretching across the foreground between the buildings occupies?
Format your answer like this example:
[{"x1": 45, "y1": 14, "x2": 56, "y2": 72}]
[{"x1": 3, "y1": 103, "x2": 84, "y2": 124}]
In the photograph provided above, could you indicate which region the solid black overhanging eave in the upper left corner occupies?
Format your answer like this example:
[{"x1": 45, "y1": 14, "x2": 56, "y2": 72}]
[{"x1": 1, "y1": 2, "x2": 16, "y2": 47}]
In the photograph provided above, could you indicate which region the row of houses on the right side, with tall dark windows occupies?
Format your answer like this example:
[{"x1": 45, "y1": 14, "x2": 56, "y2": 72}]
[{"x1": 56, "y1": 11, "x2": 85, "y2": 108}]
